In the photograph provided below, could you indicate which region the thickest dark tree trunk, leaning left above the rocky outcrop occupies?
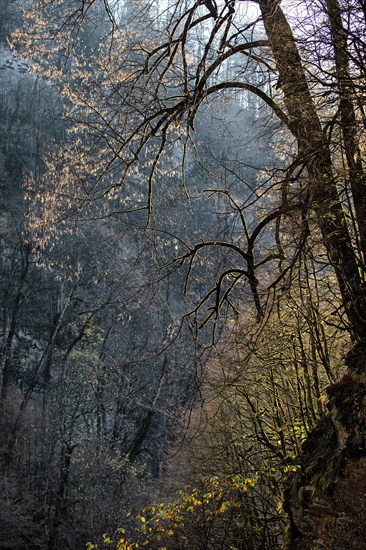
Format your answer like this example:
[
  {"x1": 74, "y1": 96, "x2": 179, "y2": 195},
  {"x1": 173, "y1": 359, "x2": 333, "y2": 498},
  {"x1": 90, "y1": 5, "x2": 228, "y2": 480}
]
[{"x1": 259, "y1": 0, "x2": 366, "y2": 342}]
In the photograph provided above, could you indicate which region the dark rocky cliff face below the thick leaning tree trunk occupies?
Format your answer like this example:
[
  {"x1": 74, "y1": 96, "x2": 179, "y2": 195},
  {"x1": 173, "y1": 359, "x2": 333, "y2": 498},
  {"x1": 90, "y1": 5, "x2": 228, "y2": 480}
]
[{"x1": 286, "y1": 345, "x2": 366, "y2": 550}]
